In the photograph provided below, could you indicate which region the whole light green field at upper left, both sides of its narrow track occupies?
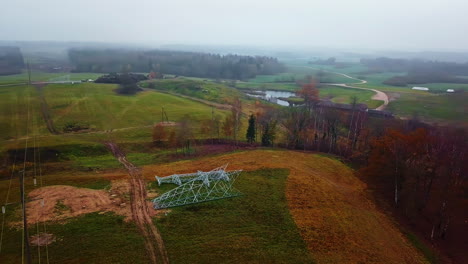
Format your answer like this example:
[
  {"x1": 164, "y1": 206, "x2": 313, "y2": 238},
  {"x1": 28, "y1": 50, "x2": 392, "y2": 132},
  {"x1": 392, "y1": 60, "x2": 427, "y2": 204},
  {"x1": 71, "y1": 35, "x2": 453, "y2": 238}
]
[{"x1": 0, "y1": 83, "x2": 230, "y2": 144}]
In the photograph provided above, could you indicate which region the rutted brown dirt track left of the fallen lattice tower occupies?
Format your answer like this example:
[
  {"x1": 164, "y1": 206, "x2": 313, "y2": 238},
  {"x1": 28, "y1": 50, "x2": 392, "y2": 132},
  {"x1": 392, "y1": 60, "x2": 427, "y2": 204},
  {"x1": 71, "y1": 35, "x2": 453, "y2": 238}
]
[{"x1": 105, "y1": 142, "x2": 169, "y2": 263}]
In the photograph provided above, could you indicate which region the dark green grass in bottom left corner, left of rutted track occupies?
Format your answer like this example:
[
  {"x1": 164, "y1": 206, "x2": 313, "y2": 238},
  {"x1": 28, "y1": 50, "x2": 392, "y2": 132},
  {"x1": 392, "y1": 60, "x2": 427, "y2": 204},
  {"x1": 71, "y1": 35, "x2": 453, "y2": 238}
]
[{"x1": 2, "y1": 213, "x2": 148, "y2": 264}]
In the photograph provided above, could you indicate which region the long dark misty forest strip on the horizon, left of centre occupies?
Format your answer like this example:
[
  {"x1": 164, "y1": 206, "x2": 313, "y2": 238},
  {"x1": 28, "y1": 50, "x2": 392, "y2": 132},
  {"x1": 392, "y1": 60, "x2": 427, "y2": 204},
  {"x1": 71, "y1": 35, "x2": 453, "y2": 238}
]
[{"x1": 68, "y1": 49, "x2": 286, "y2": 80}]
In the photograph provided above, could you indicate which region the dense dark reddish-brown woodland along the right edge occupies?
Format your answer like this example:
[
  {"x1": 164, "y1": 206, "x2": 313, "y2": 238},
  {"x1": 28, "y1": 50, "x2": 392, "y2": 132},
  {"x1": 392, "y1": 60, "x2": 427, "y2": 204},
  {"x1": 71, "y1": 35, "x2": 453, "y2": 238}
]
[{"x1": 361, "y1": 121, "x2": 468, "y2": 242}]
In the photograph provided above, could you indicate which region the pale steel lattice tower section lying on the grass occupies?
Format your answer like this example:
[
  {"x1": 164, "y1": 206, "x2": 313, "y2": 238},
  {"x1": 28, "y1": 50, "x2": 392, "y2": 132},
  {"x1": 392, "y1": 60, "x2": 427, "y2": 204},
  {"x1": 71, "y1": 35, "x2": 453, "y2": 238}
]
[{"x1": 153, "y1": 165, "x2": 242, "y2": 209}]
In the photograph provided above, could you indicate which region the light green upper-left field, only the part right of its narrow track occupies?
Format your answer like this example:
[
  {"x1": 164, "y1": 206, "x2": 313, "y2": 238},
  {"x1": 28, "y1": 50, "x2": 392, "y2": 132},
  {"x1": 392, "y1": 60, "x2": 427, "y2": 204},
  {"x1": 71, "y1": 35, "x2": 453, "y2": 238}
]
[{"x1": 44, "y1": 83, "x2": 225, "y2": 130}]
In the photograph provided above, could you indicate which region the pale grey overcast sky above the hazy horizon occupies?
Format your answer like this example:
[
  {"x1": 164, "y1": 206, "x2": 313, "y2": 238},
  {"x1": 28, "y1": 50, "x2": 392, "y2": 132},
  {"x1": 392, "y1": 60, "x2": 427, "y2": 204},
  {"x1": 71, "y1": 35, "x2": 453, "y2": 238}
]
[{"x1": 0, "y1": 0, "x2": 468, "y2": 51}]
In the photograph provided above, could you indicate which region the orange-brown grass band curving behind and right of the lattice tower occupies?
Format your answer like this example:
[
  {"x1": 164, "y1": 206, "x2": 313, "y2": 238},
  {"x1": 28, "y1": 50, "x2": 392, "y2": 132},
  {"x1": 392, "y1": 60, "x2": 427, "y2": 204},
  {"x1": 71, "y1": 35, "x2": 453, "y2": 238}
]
[{"x1": 143, "y1": 150, "x2": 425, "y2": 263}]
